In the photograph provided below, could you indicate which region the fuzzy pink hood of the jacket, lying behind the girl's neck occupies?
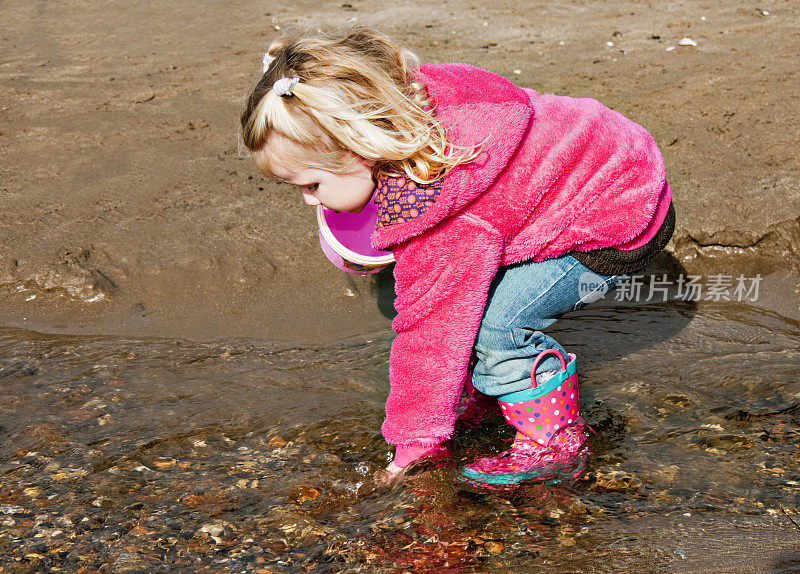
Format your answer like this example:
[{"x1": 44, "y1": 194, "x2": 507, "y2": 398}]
[{"x1": 372, "y1": 64, "x2": 533, "y2": 249}]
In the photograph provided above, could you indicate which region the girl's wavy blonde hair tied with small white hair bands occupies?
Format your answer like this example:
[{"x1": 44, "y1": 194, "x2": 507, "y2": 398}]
[{"x1": 241, "y1": 27, "x2": 478, "y2": 183}]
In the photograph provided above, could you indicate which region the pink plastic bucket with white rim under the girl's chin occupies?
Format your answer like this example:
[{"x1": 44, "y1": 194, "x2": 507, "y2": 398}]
[{"x1": 317, "y1": 201, "x2": 394, "y2": 275}]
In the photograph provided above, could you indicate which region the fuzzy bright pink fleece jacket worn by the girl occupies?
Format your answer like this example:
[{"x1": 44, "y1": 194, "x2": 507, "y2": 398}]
[{"x1": 372, "y1": 64, "x2": 665, "y2": 447}]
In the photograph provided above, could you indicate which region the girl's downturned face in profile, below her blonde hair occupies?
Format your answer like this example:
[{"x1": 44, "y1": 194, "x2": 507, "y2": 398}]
[{"x1": 256, "y1": 135, "x2": 375, "y2": 213}]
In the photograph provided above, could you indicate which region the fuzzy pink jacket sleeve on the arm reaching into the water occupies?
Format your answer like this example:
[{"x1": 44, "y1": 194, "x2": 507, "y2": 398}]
[{"x1": 382, "y1": 216, "x2": 502, "y2": 446}]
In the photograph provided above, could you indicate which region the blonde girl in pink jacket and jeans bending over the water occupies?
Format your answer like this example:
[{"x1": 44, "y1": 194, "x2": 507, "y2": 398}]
[{"x1": 241, "y1": 28, "x2": 675, "y2": 483}]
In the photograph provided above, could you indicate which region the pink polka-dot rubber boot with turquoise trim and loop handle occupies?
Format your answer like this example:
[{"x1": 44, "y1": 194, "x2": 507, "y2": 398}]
[{"x1": 462, "y1": 349, "x2": 590, "y2": 484}]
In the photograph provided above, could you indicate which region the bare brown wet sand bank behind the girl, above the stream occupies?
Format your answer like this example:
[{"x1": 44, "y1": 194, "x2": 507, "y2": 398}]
[{"x1": 0, "y1": 1, "x2": 800, "y2": 340}]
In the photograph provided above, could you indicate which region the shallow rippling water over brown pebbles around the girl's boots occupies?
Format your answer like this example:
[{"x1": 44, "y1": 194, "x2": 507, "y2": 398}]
[{"x1": 0, "y1": 302, "x2": 800, "y2": 572}]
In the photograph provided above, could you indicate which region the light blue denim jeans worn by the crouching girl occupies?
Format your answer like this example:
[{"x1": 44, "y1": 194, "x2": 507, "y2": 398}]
[{"x1": 472, "y1": 255, "x2": 632, "y2": 396}]
